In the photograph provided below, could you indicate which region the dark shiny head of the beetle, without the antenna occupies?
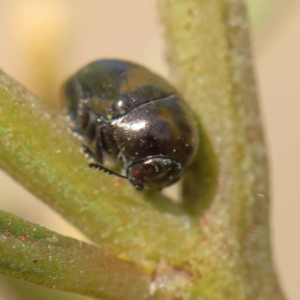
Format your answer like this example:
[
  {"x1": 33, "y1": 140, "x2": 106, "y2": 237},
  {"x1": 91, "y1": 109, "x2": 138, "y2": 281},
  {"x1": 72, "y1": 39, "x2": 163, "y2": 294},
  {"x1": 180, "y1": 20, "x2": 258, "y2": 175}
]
[{"x1": 127, "y1": 157, "x2": 182, "y2": 190}]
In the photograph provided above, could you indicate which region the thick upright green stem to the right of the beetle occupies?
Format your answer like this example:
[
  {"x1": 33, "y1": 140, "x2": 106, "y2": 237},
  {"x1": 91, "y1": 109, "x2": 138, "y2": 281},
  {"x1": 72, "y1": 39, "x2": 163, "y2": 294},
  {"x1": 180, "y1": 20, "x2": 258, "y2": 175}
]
[{"x1": 159, "y1": 0, "x2": 283, "y2": 300}]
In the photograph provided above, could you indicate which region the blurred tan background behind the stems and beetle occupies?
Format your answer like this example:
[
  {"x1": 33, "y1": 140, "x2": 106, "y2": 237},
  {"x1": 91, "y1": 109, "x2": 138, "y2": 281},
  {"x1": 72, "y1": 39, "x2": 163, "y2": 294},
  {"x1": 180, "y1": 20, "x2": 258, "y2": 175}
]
[{"x1": 0, "y1": 0, "x2": 300, "y2": 300}]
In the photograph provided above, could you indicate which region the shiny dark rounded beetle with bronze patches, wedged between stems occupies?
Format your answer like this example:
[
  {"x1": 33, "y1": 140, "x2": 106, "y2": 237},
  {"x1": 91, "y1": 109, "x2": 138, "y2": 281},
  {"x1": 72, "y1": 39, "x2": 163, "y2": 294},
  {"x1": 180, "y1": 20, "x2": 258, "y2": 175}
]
[{"x1": 64, "y1": 60, "x2": 198, "y2": 190}]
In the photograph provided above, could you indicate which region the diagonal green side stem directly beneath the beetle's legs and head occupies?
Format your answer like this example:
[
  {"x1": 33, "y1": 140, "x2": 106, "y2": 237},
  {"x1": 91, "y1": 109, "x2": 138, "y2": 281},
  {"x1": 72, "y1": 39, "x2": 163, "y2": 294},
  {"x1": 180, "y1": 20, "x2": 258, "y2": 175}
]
[{"x1": 0, "y1": 68, "x2": 197, "y2": 262}]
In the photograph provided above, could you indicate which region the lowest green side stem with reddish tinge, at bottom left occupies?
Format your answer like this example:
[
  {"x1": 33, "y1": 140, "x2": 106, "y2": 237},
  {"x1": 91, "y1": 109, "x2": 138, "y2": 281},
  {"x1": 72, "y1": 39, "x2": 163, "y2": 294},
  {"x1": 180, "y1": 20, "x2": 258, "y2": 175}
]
[{"x1": 0, "y1": 211, "x2": 158, "y2": 300}]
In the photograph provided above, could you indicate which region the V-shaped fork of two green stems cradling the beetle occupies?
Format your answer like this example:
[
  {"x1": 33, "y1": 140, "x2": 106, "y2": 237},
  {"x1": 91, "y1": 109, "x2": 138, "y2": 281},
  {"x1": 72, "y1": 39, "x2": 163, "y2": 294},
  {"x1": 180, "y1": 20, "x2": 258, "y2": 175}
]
[{"x1": 0, "y1": 0, "x2": 283, "y2": 300}]
